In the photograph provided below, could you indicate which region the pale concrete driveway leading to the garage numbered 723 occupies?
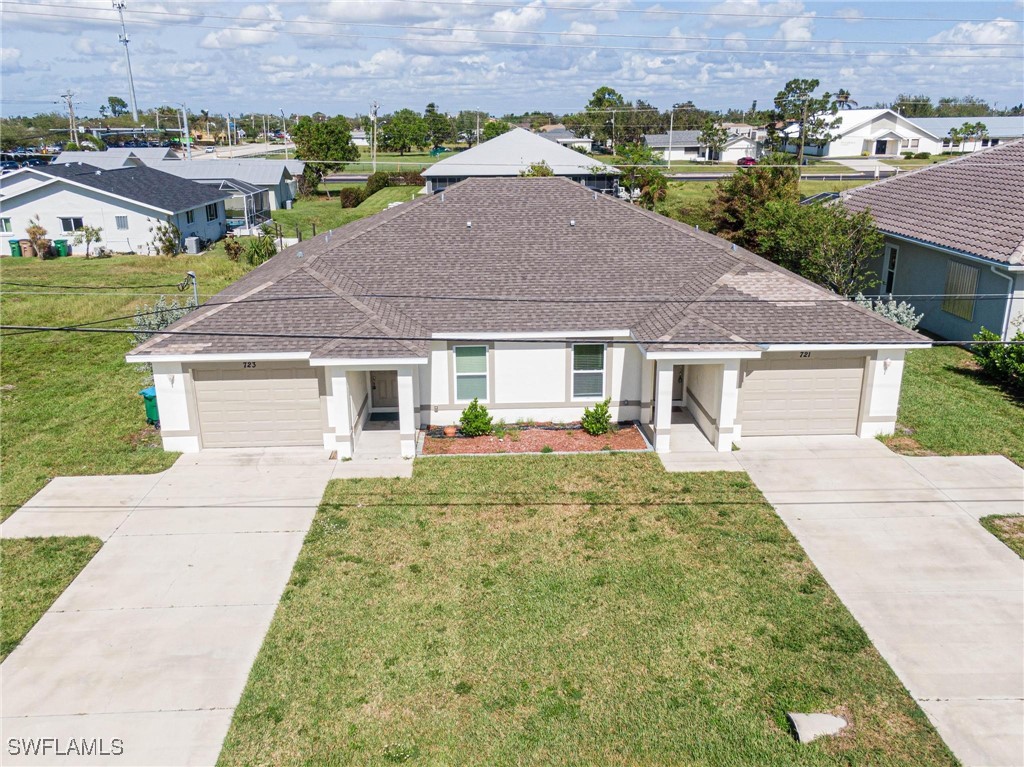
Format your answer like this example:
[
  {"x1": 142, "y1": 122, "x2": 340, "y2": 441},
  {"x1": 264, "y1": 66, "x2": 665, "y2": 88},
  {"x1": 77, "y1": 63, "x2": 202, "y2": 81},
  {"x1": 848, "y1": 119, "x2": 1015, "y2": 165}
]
[{"x1": 0, "y1": 449, "x2": 337, "y2": 767}]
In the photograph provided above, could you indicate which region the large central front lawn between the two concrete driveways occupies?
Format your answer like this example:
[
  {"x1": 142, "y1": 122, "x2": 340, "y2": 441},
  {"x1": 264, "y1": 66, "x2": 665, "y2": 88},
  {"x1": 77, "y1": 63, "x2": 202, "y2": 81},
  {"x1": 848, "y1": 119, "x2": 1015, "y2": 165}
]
[{"x1": 219, "y1": 454, "x2": 954, "y2": 767}]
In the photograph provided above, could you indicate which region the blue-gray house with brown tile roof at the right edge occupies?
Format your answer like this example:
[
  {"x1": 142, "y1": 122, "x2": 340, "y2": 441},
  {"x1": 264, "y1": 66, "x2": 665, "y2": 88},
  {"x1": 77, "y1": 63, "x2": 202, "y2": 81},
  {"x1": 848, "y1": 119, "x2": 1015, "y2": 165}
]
[{"x1": 842, "y1": 139, "x2": 1024, "y2": 341}]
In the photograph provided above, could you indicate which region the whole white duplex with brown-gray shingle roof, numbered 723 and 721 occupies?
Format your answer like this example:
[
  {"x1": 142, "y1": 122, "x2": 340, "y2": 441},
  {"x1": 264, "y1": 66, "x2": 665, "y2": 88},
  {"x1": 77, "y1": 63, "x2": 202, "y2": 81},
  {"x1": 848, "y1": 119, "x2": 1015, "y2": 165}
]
[{"x1": 128, "y1": 176, "x2": 928, "y2": 458}]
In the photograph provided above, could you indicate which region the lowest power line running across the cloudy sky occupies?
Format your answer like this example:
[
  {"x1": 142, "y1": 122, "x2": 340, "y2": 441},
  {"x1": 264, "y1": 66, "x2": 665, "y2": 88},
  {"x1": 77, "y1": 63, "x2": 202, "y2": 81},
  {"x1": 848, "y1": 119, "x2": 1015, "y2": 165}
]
[{"x1": 4, "y1": 6, "x2": 1024, "y2": 59}]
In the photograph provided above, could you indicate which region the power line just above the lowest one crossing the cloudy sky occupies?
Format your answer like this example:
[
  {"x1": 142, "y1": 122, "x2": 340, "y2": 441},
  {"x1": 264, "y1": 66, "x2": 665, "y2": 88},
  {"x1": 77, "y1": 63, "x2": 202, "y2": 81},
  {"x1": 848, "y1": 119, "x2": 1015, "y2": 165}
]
[{"x1": 7, "y1": 0, "x2": 1016, "y2": 48}]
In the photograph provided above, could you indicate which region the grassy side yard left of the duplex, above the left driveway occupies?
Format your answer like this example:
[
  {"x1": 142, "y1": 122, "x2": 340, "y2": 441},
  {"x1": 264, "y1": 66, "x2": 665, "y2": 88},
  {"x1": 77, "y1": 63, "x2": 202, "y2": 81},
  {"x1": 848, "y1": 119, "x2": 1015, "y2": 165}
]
[{"x1": 0, "y1": 256, "x2": 252, "y2": 518}]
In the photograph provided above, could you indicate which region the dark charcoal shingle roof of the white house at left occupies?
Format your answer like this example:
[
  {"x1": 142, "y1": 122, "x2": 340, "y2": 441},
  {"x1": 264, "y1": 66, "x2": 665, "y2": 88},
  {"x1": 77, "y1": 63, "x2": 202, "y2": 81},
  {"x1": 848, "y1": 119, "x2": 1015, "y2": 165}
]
[{"x1": 32, "y1": 163, "x2": 231, "y2": 213}]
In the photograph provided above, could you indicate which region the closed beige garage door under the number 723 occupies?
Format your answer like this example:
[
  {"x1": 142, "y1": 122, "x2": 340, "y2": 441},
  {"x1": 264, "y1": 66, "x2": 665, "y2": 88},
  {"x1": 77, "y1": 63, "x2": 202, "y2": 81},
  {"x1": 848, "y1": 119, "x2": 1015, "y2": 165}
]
[{"x1": 193, "y1": 361, "x2": 324, "y2": 448}]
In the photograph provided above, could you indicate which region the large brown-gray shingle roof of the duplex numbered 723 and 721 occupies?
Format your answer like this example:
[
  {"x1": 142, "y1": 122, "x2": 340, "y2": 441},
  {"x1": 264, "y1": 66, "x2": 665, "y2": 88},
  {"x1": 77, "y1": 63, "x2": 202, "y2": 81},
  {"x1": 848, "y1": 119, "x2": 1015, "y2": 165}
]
[{"x1": 132, "y1": 176, "x2": 923, "y2": 358}]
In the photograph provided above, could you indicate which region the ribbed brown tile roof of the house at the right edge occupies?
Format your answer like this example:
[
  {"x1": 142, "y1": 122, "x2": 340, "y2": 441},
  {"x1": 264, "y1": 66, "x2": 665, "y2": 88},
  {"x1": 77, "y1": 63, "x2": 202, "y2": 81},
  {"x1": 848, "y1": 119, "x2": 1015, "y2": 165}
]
[{"x1": 841, "y1": 140, "x2": 1024, "y2": 264}]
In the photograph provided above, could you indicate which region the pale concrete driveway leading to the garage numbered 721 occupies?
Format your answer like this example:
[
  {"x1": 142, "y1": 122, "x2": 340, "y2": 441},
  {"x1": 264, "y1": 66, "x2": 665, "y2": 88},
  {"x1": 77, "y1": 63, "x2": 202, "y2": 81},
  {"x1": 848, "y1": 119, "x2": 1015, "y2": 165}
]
[{"x1": 733, "y1": 437, "x2": 1024, "y2": 767}]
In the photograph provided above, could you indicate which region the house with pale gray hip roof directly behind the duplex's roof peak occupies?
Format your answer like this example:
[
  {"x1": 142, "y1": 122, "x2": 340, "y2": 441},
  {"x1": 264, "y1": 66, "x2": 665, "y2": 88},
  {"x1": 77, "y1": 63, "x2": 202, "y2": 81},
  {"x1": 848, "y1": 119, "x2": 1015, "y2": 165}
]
[{"x1": 422, "y1": 128, "x2": 620, "y2": 194}]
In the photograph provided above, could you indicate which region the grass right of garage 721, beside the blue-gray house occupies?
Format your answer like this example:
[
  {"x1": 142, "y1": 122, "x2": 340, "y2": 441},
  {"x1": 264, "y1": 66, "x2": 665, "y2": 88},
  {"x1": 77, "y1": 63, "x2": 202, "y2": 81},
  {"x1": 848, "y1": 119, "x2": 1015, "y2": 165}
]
[{"x1": 885, "y1": 346, "x2": 1024, "y2": 466}]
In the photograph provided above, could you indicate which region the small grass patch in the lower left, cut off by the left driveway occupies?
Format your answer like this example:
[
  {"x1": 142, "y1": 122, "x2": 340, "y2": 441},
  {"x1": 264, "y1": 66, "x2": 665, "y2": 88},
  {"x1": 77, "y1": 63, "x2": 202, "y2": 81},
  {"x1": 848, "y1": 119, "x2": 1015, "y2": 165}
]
[{"x1": 0, "y1": 537, "x2": 101, "y2": 661}]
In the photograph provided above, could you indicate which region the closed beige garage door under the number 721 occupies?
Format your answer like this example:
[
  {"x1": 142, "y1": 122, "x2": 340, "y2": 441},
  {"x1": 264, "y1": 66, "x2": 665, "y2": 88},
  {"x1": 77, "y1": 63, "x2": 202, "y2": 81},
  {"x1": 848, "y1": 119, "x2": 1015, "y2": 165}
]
[{"x1": 739, "y1": 352, "x2": 864, "y2": 436}]
